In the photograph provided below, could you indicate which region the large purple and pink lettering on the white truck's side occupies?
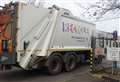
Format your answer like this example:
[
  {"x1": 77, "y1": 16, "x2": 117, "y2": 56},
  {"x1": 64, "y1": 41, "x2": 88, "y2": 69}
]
[{"x1": 62, "y1": 22, "x2": 89, "y2": 34}]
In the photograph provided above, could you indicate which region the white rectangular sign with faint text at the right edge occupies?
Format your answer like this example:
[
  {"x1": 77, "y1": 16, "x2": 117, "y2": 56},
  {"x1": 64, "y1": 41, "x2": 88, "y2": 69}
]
[{"x1": 107, "y1": 48, "x2": 120, "y2": 61}]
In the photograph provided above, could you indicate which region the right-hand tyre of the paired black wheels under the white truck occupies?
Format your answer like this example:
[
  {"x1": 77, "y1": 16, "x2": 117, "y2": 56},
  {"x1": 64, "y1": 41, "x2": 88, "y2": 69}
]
[{"x1": 64, "y1": 53, "x2": 77, "y2": 72}]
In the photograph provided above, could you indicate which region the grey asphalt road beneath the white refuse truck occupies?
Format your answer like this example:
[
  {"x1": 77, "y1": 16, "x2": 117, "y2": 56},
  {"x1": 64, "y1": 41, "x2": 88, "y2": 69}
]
[{"x1": 0, "y1": 65, "x2": 103, "y2": 82}]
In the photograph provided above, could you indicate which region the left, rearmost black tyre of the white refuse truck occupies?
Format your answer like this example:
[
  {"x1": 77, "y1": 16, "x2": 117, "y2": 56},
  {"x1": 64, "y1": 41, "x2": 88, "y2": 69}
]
[{"x1": 46, "y1": 53, "x2": 63, "y2": 75}]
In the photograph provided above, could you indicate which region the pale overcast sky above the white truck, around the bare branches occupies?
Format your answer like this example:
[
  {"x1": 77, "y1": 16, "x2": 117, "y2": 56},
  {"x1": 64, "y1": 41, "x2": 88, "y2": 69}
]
[{"x1": 0, "y1": 0, "x2": 120, "y2": 35}]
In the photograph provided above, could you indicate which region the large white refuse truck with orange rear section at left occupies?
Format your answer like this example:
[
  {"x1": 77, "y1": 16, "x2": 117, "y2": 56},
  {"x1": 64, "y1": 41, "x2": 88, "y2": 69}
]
[{"x1": 0, "y1": 3, "x2": 96, "y2": 74}]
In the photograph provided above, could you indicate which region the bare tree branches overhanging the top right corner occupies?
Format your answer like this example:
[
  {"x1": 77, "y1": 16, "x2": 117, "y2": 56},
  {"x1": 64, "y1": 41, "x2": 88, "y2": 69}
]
[{"x1": 77, "y1": 0, "x2": 120, "y2": 19}]
